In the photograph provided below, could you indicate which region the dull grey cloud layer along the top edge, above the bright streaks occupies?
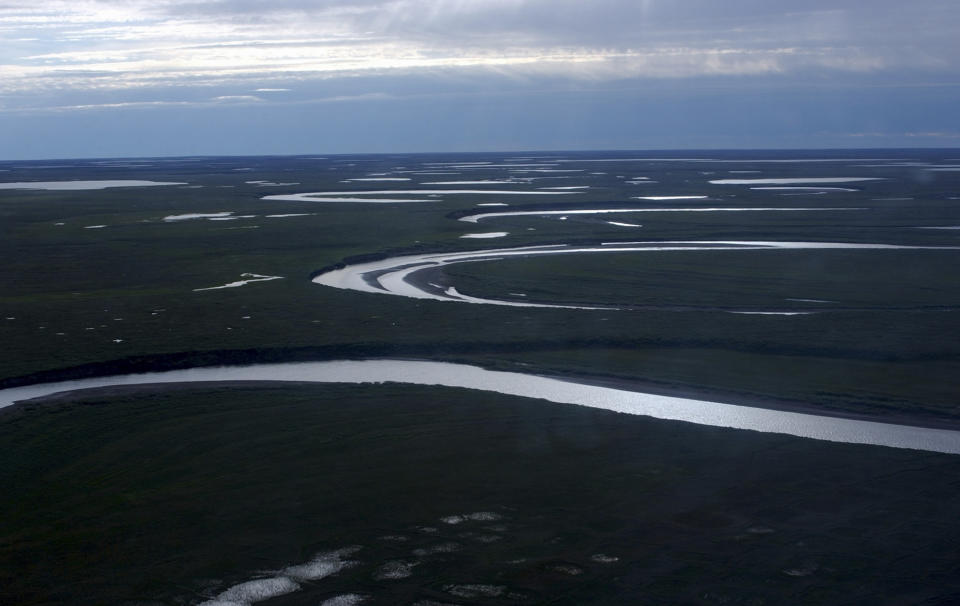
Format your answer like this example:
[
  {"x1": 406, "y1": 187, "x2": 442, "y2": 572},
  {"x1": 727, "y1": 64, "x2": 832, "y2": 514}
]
[{"x1": 152, "y1": 0, "x2": 960, "y2": 59}]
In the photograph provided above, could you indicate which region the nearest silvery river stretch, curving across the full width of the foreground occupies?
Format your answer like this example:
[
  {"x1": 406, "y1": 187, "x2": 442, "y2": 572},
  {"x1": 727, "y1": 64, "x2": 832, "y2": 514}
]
[{"x1": 0, "y1": 360, "x2": 960, "y2": 454}]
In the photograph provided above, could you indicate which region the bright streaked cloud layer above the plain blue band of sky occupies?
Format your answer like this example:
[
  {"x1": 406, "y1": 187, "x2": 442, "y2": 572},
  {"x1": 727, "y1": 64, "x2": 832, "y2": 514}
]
[{"x1": 0, "y1": 0, "x2": 960, "y2": 117}]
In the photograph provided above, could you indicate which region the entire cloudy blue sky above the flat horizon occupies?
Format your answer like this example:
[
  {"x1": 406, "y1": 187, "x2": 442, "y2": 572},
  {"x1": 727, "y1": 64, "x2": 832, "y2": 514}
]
[{"x1": 0, "y1": 0, "x2": 960, "y2": 160}]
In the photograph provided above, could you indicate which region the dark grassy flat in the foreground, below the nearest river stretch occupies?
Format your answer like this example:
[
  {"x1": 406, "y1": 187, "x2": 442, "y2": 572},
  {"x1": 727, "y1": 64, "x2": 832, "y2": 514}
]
[{"x1": 0, "y1": 386, "x2": 960, "y2": 605}]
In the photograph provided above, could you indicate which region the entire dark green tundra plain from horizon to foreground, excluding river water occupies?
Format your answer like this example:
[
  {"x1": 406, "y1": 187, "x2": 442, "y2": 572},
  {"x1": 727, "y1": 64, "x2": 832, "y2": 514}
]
[{"x1": 0, "y1": 149, "x2": 960, "y2": 606}]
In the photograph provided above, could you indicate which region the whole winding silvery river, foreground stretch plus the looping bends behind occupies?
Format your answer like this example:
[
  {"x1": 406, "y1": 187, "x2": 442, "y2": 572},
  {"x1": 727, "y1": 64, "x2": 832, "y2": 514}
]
[{"x1": 9, "y1": 173, "x2": 960, "y2": 464}]
